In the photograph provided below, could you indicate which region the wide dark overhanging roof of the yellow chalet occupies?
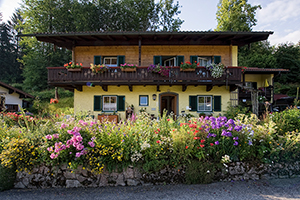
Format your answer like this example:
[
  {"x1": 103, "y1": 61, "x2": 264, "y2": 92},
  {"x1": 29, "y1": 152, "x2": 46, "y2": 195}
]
[{"x1": 18, "y1": 31, "x2": 273, "y2": 49}]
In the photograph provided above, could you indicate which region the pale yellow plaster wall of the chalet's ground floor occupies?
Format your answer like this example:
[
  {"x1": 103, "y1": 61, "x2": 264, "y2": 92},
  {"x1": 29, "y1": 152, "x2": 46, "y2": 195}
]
[{"x1": 74, "y1": 85, "x2": 230, "y2": 119}]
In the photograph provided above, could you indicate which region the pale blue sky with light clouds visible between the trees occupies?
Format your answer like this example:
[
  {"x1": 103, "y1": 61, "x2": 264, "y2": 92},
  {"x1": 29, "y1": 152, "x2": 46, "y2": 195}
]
[{"x1": 0, "y1": 0, "x2": 300, "y2": 45}]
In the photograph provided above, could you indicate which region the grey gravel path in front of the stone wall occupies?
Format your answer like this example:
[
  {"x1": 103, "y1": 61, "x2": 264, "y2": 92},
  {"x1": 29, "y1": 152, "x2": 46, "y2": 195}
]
[{"x1": 0, "y1": 178, "x2": 300, "y2": 200}]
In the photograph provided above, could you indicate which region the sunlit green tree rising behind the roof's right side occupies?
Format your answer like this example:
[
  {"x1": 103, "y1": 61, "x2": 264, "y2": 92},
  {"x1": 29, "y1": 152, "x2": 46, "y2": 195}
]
[{"x1": 215, "y1": 0, "x2": 261, "y2": 31}]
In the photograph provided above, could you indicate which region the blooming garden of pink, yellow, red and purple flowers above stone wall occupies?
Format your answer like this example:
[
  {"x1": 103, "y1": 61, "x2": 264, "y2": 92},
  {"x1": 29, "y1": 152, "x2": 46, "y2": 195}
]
[{"x1": 0, "y1": 104, "x2": 300, "y2": 190}]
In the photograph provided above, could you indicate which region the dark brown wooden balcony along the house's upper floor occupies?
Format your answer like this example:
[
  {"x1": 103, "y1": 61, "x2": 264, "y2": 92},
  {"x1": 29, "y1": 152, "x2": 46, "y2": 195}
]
[{"x1": 47, "y1": 67, "x2": 241, "y2": 90}]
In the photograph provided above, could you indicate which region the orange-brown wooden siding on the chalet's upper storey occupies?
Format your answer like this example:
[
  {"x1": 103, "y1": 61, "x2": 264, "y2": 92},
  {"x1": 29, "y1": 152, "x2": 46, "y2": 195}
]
[{"x1": 75, "y1": 45, "x2": 232, "y2": 66}]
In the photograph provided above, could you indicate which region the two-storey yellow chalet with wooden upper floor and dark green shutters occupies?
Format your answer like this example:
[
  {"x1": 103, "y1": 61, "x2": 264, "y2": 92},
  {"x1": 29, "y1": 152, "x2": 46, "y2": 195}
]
[{"x1": 21, "y1": 31, "x2": 284, "y2": 119}]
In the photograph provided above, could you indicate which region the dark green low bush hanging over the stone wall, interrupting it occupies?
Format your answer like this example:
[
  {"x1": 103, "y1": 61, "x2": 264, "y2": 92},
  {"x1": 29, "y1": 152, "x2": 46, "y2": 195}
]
[{"x1": 185, "y1": 160, "x2": 216, "y2": 184}]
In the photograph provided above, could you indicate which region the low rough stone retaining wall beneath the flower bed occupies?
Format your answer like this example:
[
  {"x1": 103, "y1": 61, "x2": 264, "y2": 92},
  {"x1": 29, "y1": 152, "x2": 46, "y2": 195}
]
[{"x1": 14, "y1": 162, "x2": 300, "y2": 188}]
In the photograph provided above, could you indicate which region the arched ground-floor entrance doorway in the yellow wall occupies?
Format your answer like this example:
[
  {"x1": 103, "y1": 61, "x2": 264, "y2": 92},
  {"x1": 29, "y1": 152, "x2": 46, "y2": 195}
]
[{"x1": 159, "y1": 93, "x2": 178, "y2": 115}]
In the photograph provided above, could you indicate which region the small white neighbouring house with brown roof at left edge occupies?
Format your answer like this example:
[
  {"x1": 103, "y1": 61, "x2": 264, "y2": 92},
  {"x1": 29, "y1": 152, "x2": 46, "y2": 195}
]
[{"x1": 0, "y1": 81, "x2": 34, "y2": 112}]
